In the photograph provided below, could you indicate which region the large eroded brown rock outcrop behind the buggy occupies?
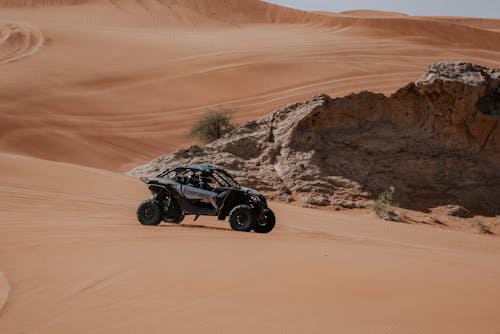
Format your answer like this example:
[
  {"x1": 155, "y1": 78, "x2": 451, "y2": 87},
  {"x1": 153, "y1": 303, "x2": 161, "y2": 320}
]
[{"x1": 131, "y1": 62, "x2": 500, "y2": 211}]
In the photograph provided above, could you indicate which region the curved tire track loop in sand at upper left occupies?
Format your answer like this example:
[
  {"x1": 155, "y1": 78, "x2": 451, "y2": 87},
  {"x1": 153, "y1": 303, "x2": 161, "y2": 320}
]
[{"x1": 0, "y1": 22, "x2": 44, "y2": 64}]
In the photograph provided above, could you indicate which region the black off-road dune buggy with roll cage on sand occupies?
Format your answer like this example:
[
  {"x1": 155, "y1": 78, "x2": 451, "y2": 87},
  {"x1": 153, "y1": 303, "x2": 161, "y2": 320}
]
[{"x1": 137, "y1": 165, "x2": 276, "y2": 233}]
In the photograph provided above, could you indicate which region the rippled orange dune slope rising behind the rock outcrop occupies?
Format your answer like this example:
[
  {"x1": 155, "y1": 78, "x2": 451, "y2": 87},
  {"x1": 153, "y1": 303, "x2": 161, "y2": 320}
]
[{"x1": 0, "y1": 0, "x2": 500, "y2": 171}]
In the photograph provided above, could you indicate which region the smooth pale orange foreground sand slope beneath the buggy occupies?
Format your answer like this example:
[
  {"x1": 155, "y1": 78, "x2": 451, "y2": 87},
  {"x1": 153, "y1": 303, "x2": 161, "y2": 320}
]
[{"x1": 0, "y1": 154, "x2": 500, "y2": 333}]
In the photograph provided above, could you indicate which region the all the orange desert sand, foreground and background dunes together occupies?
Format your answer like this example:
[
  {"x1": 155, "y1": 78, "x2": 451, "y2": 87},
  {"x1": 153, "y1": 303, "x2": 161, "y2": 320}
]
[{"x1": 0, "y1": 0, "x2": 500, "y2": 333}]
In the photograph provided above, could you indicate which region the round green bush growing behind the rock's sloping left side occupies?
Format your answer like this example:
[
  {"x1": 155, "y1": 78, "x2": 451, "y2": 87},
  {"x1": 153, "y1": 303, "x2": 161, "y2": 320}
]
[{"x1": 189, "y1": 107, "x2": 236, "y2": 143}]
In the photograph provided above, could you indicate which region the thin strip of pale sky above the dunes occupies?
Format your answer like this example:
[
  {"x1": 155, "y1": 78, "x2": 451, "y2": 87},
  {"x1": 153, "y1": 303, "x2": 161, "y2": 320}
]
[{"x1": 266, "y1": 0, "x2": 500, "y2": 19}]
